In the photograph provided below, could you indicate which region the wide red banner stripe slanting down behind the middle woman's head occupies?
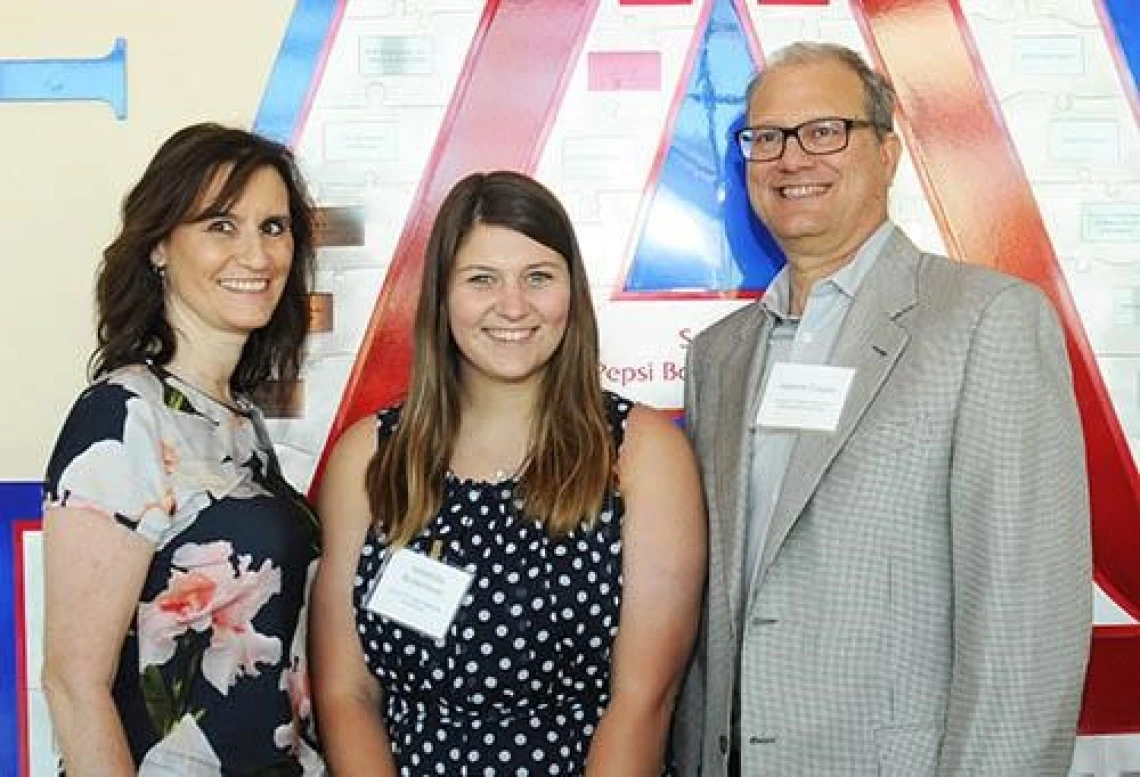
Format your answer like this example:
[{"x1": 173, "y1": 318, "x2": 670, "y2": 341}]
[{"x1": 311, "y1": 0, "x2": 599, "y2": 492}]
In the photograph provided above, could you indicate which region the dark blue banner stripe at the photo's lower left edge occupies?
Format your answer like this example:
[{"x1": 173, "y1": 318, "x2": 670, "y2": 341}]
[{"x1": 0, "y1": 482, "x2": 43, "y2": 774}]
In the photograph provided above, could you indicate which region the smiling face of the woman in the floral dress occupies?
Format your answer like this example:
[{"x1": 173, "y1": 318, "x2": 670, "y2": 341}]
[{"x1": 150, "y1": 167, "x2": 293, "y2": 351}]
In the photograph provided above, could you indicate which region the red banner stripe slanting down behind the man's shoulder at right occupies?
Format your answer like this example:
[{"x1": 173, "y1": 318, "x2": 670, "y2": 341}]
[{"x1": 852, "y1": 0, "x2": 1140, "y2": 734}]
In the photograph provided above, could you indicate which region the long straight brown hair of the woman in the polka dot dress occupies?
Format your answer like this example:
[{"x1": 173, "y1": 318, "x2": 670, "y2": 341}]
[{"x1": 365, "y1": 171, "x2": 617, "y2": 543}]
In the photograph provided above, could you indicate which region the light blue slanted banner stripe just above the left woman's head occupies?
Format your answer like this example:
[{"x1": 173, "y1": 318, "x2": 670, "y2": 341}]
[{"x1": 253, "y1": 0, "x2": 344, "y2": 144}]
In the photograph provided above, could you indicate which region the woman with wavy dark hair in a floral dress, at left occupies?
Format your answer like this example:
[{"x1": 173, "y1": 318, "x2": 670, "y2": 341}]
[{"x1": 43, "y1": 124, "x2": 324, "y2": 777}]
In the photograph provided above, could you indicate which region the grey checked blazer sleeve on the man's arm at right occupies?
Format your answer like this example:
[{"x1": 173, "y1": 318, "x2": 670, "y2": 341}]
[{"x1": 938, "y1": 284, "x2": 1092, "y2": 777}]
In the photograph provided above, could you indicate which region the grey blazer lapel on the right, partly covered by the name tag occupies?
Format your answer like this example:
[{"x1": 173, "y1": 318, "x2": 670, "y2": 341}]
[{"x1": 751, "y1": 235, "x2": 920, "y2": 590}]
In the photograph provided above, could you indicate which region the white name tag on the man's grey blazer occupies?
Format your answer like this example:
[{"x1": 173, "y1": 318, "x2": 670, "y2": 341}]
[{"x1": 756, "y1": 361, "x2": 855, "y2": 432}]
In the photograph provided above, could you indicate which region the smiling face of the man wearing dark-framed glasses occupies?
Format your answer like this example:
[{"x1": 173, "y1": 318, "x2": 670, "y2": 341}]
[{"x1": 748, "y1": 59, "x2": 901, "y2": 267}]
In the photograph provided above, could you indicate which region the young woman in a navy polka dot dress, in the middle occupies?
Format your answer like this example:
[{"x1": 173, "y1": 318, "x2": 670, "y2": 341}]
[{"x1": 310, "y1": 167, "x2": 705, "y2": 777}]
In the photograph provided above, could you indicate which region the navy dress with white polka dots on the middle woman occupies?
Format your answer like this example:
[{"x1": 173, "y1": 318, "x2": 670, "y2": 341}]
[{"x1": 353, "y1": 395, "x2": 665, "y2": 777}]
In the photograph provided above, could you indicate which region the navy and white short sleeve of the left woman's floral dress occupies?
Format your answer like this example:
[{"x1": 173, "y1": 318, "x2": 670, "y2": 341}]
[{"x1": 44, "y1": 382, "x2": 174, "y2": 545}]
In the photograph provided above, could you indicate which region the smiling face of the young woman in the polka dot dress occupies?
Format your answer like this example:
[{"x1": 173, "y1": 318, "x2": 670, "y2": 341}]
[{"x1": 447, "y1": 223, "x2": 570, "y2": 394}]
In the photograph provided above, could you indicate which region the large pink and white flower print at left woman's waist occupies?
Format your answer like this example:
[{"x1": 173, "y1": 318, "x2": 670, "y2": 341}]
[{"x1": 138, "y1": 540, "x2": 282, "y2": 695}]
